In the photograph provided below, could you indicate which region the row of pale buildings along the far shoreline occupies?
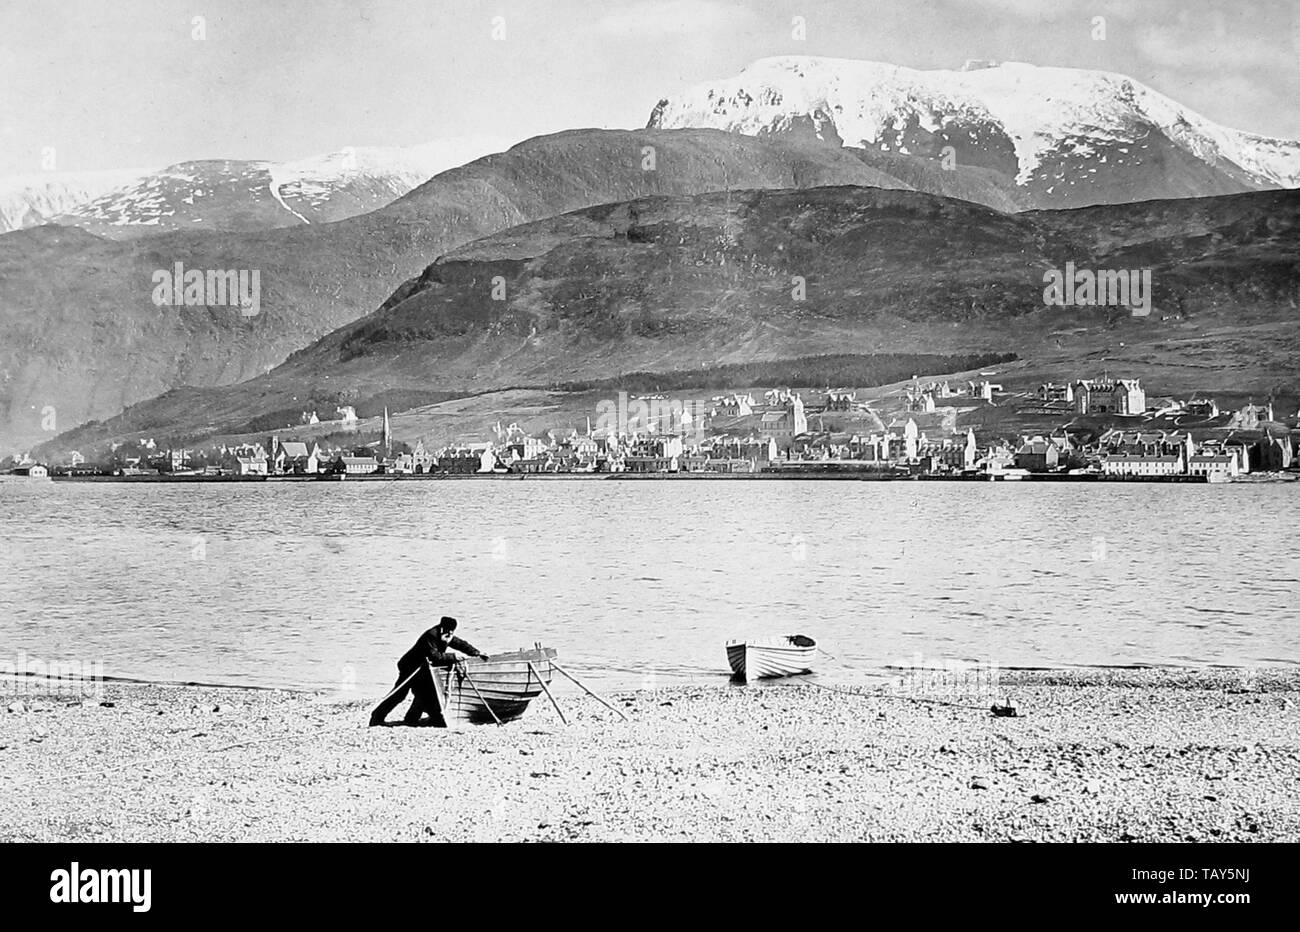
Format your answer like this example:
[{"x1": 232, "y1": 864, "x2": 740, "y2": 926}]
[{"x1": 20, "y1": 377, "x2": 1300, "y2": 478}]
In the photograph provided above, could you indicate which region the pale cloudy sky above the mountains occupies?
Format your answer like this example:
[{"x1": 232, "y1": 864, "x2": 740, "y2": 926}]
[{"x1": 0, "y1": 0, "x2": 1300, "y2": 177}]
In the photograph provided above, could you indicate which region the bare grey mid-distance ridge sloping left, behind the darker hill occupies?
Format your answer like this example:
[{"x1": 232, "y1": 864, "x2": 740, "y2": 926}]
[{"x1": 0, "y1": 130, "x2": 904, "y2": 450}]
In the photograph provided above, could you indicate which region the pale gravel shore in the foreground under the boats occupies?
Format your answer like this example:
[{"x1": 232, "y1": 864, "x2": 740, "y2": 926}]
[{"x1": 0, "y1": 669, "x2": 1300, "y2": 841}]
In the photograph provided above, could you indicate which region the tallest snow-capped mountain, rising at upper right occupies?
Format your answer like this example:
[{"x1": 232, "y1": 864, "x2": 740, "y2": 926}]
[{"x1": 649, "y1": 56, "x2": 1300, "y2": 207}]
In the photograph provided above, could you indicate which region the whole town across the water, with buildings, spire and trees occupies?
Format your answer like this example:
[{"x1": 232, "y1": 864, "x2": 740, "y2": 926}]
[{"x1": 12, "y1": 377, "x2": 1300, "y2": 482}]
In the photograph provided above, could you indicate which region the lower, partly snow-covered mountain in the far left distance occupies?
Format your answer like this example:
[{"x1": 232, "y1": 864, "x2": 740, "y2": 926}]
[{"x1": 0, "y1": 138, "x2": 506, "y2": 239}]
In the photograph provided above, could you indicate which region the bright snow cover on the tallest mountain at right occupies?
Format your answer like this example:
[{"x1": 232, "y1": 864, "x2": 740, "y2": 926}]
[{"x1": 650, "y1": 56, "x2": 1300, "y2": 187}]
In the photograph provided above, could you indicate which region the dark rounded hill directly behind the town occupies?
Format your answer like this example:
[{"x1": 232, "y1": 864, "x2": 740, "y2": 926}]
[{"x1": 38, "y1": 186, "x2": 1300, "y2": 446}]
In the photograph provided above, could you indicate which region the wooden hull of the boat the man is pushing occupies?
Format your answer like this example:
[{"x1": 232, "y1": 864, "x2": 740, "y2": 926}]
[{"x1": 434, "y1": 647, "x2": 556, "y2": 725}]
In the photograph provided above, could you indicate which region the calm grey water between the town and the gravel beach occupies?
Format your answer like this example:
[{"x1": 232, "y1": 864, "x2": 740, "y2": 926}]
[{"x1": 0, "y1": 480, "x2": 1300, "y2": 693}]
